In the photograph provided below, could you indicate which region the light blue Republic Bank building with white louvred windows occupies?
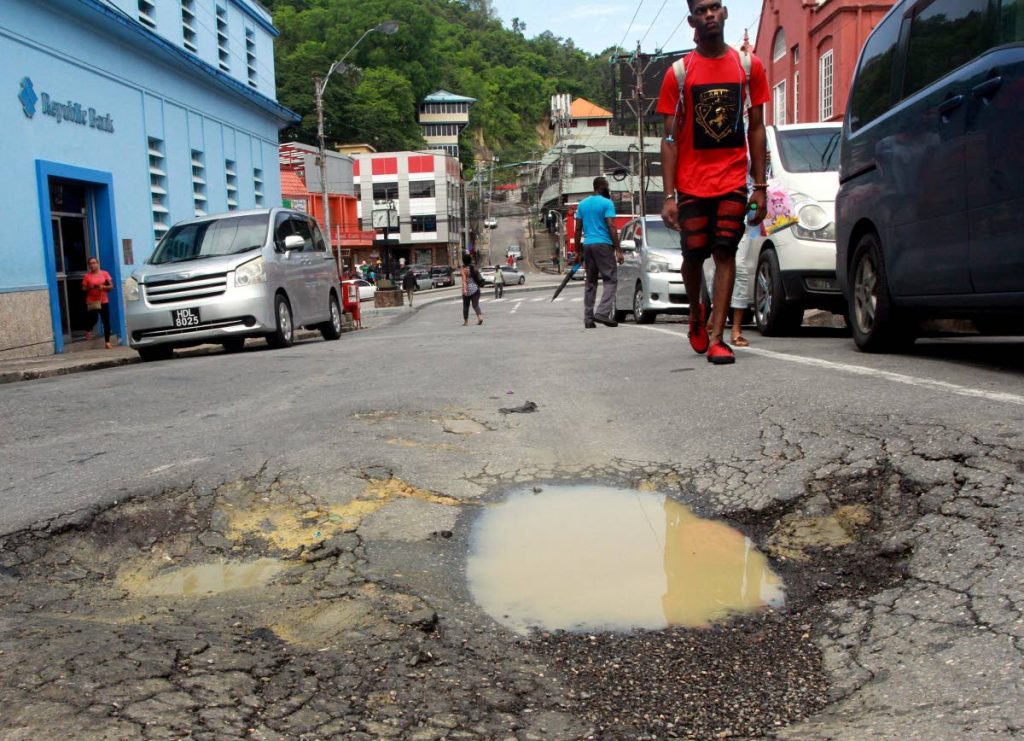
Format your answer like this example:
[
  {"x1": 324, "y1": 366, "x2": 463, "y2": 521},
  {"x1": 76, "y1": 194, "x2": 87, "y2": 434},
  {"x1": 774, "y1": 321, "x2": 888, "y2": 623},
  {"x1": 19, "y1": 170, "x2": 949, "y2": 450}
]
[{"x1": 0, "y1": 0, "x2": 297, "y2": 358}]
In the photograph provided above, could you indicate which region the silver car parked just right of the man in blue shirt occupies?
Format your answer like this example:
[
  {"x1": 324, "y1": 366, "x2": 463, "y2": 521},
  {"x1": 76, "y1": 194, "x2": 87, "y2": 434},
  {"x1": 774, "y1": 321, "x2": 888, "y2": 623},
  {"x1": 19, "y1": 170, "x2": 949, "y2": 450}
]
[{"x1": 615, "y1": 216, "x2": 690, "y2": 324}]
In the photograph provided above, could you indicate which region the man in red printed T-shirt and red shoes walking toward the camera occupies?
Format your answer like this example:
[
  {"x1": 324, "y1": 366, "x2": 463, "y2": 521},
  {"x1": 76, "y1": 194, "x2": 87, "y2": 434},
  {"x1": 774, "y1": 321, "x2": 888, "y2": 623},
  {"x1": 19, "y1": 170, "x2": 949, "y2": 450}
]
[{"x1": 657, "y1": 0, "x2": 768, "y2": 364}]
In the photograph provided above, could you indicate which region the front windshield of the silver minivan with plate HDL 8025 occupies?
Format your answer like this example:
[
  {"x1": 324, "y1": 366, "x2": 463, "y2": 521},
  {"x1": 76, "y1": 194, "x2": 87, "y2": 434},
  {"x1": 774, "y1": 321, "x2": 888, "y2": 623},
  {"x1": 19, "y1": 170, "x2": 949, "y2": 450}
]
[{"x1": 150, "y1": 214, "x2": 269, "y2": 265}]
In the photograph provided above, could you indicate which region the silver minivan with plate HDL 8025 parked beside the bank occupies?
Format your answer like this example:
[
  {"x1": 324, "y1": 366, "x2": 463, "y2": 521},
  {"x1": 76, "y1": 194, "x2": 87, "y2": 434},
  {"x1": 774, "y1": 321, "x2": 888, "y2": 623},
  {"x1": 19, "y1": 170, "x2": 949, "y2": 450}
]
[{"x1": 125, "y1": 209, "x2": 341, "y2": 360}]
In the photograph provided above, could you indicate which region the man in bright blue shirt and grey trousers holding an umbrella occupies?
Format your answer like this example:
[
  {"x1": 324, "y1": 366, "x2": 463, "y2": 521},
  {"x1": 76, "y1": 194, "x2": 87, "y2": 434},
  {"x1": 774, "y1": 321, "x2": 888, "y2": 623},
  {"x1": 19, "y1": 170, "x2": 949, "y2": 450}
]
[{"x1": 575, "y1": 177, "x2": 623, "y2": 330}]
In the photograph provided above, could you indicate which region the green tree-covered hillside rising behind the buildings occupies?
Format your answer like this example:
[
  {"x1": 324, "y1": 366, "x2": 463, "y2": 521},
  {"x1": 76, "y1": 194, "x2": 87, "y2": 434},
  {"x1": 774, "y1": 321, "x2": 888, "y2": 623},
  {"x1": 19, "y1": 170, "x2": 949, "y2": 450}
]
[{"x1": 267, "y1": 0, "x2": 611, "y2": 166}]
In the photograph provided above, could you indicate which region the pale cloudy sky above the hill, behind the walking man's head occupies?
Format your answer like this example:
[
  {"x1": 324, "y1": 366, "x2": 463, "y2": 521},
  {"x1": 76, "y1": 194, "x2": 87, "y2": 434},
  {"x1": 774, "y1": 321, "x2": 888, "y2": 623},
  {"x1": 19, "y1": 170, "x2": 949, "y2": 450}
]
[{"x1": 493, "y1": 0, "x2": 762, "y2": 52}]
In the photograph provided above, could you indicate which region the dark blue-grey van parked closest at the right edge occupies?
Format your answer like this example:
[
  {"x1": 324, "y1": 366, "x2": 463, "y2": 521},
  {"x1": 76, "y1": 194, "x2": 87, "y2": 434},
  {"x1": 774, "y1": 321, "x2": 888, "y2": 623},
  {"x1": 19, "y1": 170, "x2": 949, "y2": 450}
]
[{"x1": 836, "y1": 0, "x2": 1024, "y2": 351}]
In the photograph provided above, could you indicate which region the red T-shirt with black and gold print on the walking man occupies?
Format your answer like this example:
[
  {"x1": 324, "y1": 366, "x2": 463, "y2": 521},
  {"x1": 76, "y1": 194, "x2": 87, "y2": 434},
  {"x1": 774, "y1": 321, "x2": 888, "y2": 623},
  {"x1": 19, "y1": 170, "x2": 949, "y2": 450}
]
[{"x1": 657, "y1": 48, "x2": 768, "y2": 199}]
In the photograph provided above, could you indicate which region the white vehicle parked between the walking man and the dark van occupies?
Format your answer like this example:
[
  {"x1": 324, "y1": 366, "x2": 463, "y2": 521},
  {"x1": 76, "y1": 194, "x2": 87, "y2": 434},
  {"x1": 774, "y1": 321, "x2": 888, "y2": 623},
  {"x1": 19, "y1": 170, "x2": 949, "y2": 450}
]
[{"x1": 748, "y1": 123, "x2": 846, "y2": 335}]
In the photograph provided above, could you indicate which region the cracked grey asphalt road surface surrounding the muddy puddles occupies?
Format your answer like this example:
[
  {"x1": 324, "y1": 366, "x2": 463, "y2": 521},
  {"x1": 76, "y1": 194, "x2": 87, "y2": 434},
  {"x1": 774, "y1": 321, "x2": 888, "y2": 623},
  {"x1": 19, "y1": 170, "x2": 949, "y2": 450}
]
[{"x1": 0, "y1": 302, "x2": 1024, "y2": 738}]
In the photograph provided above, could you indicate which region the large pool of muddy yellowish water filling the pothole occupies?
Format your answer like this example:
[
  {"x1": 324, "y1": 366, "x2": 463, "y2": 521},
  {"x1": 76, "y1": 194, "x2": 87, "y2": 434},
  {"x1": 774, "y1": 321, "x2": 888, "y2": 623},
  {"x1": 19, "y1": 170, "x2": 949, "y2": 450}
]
[{"x1": 467, "y1": 486, "x2": 784, "y2": 633}]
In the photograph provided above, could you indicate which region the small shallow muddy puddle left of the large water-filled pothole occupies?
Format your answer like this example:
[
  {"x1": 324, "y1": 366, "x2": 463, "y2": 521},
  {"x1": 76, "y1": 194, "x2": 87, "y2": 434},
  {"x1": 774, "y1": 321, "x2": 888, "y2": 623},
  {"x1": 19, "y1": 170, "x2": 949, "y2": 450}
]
[{"x1": 133, "y1": 558, "x2": 288, "y2": 597}]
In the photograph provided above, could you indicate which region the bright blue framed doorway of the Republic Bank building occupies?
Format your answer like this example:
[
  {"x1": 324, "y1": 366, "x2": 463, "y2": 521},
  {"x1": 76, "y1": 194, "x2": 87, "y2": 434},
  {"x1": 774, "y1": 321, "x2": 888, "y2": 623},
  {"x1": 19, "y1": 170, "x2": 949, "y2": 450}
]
[{"x1": 36, "y1": 160, "x2": 125, "y2": 353}]
